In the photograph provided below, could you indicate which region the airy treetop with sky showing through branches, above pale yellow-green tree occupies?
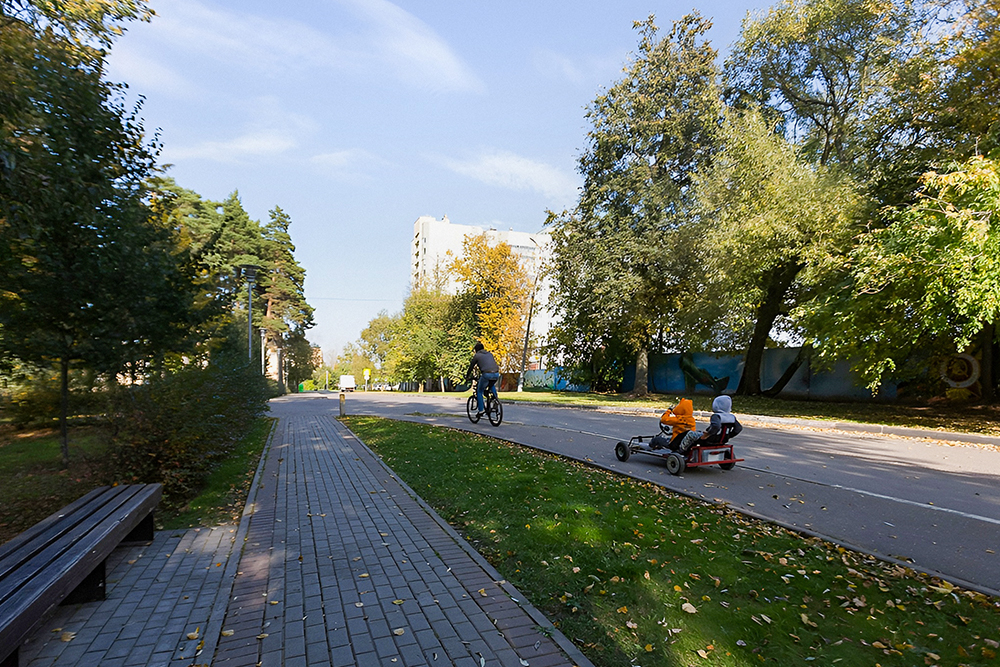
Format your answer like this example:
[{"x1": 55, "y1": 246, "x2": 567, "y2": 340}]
[{"x1": 725, "y1": 0, "x2": 916, "y2": 173}]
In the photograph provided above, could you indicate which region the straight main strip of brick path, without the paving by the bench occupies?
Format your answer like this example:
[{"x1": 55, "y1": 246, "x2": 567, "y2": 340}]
[{"x1": 213, "y1": 411, "x2": 587, "y2": 667}]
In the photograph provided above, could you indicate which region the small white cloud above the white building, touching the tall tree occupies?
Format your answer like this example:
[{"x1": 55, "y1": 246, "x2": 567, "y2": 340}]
[{"x1": 440, "y1": 151, "x2": 578, "y2": 206}]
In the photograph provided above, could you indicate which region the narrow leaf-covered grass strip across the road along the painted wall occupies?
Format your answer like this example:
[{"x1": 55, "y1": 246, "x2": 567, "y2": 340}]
[{"x1": 390, "y1": 389, "x2": 1000, "y2": 435}]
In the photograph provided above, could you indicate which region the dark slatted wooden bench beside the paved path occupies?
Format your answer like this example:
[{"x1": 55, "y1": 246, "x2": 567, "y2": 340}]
[{"x1": 0, "y1": 484, "x2": 163, "y2": 667}]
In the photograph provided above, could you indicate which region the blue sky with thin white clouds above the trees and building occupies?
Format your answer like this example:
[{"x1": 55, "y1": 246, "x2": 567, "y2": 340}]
[{"x1": 109, "y1": 0, "x2": 771, "y2": 358}]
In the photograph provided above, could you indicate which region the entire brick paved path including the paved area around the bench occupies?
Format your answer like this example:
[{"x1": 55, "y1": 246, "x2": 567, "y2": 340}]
[{"x1": 15, "y1": 396, "x2": 591, "y2": 667}]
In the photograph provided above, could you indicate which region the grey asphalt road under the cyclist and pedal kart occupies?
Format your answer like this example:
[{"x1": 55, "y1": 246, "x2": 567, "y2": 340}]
[{"x1": 312, "y1": 392, "x2": 1000, "y2": 595}]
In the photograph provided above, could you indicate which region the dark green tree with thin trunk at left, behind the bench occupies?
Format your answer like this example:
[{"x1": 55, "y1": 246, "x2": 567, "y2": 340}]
[{"x1": 0, "y1": 15, "x2": 193, "y2": 461}]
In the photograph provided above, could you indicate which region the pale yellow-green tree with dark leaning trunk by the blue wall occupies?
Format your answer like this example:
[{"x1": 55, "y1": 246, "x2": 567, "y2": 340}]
[{"x1": 687, "y1": 107, "x2": 863, "y2": 394}]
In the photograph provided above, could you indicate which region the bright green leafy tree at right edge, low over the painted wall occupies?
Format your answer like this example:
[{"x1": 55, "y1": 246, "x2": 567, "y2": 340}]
[{"x1": 802, "y1": 156, "x2": 1000, "y2": 399}]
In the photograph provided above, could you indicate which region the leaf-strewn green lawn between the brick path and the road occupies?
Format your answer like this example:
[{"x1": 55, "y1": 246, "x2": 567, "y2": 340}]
[{"x1": 345, "y1": 417, "x2": 1000, "y2": 667}]
